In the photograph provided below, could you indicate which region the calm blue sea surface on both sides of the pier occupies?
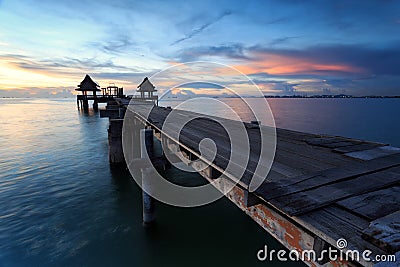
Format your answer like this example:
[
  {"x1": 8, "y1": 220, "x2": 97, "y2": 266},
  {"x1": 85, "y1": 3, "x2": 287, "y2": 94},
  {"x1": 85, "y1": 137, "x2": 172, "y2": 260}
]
[{"x1": 0, "y1": 99, "x2": 400, "y2": 267}]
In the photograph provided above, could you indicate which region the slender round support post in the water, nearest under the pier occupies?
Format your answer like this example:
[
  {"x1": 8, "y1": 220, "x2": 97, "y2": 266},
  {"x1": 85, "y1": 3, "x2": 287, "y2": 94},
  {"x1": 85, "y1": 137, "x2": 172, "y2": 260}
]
[{"x1": 140, "y1": 129, "x2": 156, "y2": 227}]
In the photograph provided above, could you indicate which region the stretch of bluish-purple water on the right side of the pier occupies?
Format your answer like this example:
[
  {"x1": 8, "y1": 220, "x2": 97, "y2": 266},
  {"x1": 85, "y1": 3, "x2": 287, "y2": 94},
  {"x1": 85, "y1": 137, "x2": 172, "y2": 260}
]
[{"x1": 160, "y1": 98, "x2": 400, "y2": 147}]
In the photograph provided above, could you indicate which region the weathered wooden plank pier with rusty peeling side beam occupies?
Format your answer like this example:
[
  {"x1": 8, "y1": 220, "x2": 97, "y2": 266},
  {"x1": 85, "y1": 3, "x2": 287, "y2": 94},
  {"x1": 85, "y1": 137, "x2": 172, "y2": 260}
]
[{"x1": 97, "y1": 98, "x2": 400, "y2": 266}]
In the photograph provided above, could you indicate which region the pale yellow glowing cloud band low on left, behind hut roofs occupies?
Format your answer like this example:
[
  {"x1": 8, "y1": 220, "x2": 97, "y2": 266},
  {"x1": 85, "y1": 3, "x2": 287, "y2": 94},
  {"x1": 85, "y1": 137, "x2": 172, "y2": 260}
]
[{"x1": 0, "y1": 54, "x2": 151, "y2": 94}]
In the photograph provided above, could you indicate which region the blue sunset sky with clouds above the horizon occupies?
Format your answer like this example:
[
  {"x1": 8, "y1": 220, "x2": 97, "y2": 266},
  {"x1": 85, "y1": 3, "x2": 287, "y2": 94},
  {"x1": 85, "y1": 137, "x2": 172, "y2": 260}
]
[{"x1": 0, "y1": 0, "x2": 400, "y2": 97}]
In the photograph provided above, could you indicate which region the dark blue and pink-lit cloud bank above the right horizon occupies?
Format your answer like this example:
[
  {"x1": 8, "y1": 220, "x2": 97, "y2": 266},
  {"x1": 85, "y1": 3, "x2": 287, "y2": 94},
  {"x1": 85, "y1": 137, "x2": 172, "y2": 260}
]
[{"x1": 170, "y1": 43, "x2": 400, "y2": 95}]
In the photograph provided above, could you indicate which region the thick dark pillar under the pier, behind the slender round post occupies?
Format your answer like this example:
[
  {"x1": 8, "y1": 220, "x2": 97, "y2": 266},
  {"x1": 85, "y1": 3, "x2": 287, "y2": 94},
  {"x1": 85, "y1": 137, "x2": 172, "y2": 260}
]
[{"x1": 108, "y1": 119, "x2": 125, "y2": 165}]
